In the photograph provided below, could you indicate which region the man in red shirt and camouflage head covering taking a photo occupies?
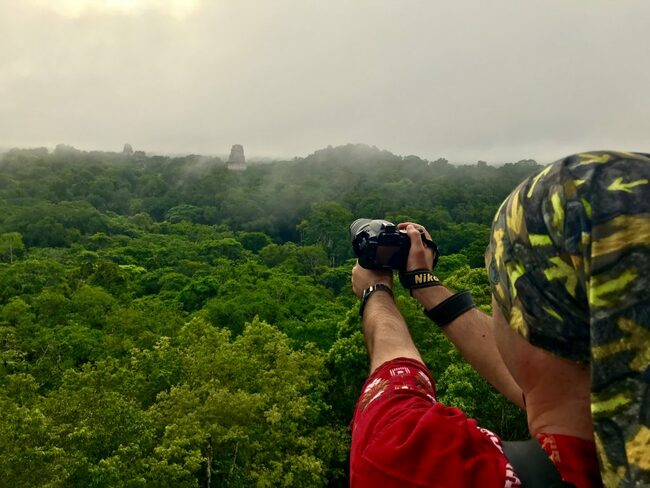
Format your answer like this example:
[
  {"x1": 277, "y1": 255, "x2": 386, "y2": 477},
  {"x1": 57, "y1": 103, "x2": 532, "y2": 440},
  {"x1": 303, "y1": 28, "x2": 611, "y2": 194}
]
[{"x1": 350, "y1": 152, "x2": 650, "y2": 487}]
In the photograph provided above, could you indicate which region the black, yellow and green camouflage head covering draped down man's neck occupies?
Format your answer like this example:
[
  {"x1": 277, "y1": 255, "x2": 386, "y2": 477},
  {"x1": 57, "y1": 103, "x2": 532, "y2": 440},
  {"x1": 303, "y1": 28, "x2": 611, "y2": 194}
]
[{"x1": 486, "y1": 152, "x2": 650, "y2": 486}]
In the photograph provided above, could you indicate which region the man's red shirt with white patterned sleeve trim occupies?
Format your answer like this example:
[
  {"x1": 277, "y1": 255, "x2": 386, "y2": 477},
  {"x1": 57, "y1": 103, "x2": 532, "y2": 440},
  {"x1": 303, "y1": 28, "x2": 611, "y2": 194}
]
[{"x1": 350, "y1": 358, "x2": 600, "y2": 488}]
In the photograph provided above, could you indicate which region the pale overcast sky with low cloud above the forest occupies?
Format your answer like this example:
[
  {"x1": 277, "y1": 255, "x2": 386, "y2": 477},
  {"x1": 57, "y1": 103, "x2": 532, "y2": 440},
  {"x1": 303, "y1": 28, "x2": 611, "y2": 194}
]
[{"x1": 0, "y1": 0, "x2": 650, "y2": 163}]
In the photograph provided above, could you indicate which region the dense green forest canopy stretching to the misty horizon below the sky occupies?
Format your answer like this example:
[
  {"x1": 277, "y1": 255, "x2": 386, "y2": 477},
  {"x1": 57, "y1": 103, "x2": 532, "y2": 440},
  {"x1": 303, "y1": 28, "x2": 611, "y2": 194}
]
[{"x1": 0, "y1": 145, "x2": 540, "y2": 488}]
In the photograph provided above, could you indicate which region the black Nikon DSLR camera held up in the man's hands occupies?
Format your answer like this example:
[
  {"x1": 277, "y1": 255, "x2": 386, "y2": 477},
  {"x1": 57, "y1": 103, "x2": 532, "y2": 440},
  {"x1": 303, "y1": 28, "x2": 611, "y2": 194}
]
[{"x1": 350, "y1": 219, "x2": 438, "y2": 271}]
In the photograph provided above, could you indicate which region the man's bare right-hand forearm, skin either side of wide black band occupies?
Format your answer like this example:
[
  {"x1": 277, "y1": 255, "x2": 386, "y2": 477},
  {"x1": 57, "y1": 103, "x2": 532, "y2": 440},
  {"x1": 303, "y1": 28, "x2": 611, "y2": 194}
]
[{"x1": 413, "y1": 286, "x2": 524, "y2": 408}]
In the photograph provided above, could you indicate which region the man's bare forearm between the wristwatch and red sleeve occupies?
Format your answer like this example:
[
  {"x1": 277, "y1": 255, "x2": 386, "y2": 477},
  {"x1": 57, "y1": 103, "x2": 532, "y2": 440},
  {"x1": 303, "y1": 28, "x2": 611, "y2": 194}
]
[{"x1": 362, "y1": 292, "x2": 422, "y2": 373}]
